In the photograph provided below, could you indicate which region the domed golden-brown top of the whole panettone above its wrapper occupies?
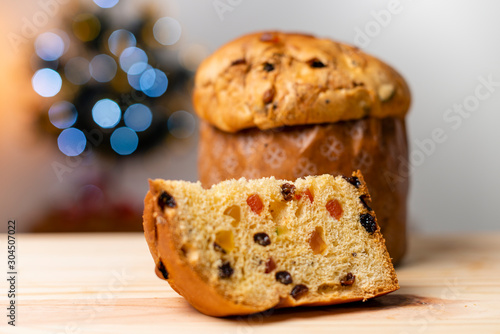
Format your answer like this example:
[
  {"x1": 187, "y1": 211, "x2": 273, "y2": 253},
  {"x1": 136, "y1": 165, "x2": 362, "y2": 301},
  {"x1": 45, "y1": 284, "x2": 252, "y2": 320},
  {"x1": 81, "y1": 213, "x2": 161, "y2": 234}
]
[{"x1": 193, "y1": 32, "x2": 410, "y2": 132}]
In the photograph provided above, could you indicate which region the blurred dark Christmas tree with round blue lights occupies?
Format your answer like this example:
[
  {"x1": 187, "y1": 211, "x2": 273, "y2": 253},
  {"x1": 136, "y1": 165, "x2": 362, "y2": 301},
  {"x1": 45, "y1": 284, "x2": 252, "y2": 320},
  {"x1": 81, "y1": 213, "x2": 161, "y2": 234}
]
[{"x1": 28, "y1": 0, "x2": 200, "y2": 231}]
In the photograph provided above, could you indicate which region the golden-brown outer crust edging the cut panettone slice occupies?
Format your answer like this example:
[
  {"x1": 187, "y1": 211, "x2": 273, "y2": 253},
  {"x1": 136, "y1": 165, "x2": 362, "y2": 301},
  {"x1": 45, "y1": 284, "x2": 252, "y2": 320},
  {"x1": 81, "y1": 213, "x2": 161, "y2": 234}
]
[{"x1": 143, "y1": 172, "x2": 399, "y2": 317}]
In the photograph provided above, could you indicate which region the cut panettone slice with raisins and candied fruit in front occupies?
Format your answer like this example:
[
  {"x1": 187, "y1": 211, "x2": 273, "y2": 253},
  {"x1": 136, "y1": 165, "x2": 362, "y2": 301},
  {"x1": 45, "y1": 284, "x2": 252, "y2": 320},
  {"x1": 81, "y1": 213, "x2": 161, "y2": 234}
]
[{"x1": 144, "y1": 173, "x2": 399, "y2": 316}]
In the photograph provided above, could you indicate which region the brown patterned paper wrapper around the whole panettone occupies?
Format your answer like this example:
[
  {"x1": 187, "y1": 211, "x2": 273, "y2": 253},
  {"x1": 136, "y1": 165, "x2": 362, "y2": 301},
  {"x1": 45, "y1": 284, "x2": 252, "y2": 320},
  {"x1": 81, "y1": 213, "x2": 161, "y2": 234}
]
[{"x1": 198, "y1": 117, "x2": 408, "y2": 263}]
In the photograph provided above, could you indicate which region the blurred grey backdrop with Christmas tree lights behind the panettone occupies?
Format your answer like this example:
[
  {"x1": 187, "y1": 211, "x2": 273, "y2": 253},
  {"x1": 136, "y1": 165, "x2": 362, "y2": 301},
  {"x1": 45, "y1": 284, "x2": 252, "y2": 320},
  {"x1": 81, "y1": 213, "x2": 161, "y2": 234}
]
[{"x1": 0, "y1": 0, "x2": 500, "y2": 232}]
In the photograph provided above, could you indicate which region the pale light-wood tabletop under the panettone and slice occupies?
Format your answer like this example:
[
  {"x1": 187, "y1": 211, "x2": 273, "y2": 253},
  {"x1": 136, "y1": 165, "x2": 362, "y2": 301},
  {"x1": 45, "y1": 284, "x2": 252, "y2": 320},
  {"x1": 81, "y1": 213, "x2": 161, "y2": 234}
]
[{"x1": 5, "y1": 233, "x2": 500, "y2": 334}]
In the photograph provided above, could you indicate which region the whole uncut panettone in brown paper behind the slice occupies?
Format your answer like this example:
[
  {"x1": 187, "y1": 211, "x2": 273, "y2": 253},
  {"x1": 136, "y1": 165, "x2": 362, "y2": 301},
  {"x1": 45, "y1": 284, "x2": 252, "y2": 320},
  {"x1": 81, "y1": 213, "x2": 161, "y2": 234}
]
[{"x1": 193, "y1": 31, "x2": 411, "y2": 263}]
